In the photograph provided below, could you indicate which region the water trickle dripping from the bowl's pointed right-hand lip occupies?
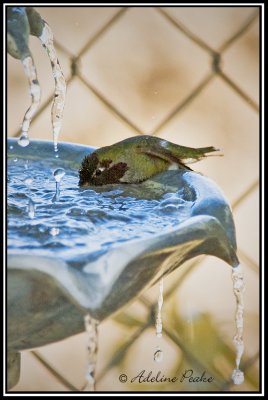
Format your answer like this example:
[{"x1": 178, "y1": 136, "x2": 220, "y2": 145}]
[{"x1": 232, "y1": 265, "x2": 245, "y2": 385}]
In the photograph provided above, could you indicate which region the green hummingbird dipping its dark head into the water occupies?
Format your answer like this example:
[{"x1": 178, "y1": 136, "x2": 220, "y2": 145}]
[{"x1": 79, "y1": 135, "x2": 219, "y2": 187}]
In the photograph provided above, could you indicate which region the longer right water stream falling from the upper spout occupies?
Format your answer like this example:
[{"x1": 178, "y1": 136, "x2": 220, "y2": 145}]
[{"x1": 39, "y1": 23, "x2": 66, "y2": 156}]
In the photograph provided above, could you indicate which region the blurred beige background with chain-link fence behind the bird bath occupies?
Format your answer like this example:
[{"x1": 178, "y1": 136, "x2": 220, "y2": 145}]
[{"x1": 7, "y1": 7, "x2": 259, "y2": 392}]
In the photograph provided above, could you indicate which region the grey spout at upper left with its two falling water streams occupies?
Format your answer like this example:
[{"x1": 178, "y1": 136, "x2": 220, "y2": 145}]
[{"x1": 7, "y1": 7, "x2": 66, "y2": 152}]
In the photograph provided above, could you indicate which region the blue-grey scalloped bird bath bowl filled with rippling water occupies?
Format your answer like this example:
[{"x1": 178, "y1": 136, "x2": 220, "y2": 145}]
[{"x1": 7, "y1": 139, "x2": 243, "y2": 386}]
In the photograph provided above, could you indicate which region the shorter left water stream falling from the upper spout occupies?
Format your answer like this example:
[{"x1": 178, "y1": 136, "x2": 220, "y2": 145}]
[{"x1": 18, "y1": 56, "x2": 41, "y2": 147}]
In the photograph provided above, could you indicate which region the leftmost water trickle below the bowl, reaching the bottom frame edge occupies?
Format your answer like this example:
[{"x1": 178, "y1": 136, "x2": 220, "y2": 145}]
[{"x1": 84, "y1": 314, "x2": 99, "y2": 392}]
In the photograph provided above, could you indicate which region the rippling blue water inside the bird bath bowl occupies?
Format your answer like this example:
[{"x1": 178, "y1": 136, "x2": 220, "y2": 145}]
[{"x1": 7, "y1": 153, "x2": 192, "y2": 266}]
